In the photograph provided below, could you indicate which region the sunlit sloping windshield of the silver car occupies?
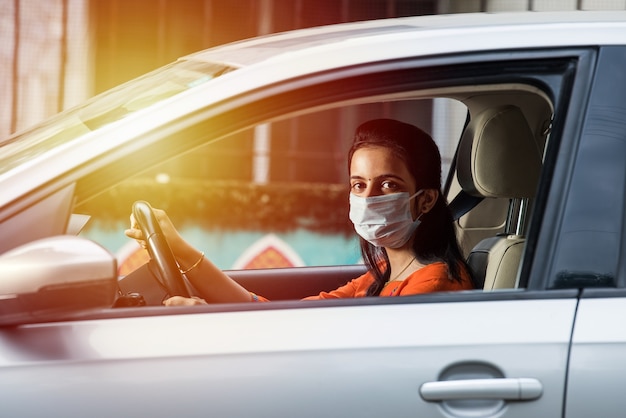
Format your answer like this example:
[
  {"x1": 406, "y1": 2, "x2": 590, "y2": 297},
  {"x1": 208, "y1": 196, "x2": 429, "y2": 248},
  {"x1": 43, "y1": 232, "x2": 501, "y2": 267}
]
[{"x1": 0, "y1": 61, "x2": 235, "y2": 174}]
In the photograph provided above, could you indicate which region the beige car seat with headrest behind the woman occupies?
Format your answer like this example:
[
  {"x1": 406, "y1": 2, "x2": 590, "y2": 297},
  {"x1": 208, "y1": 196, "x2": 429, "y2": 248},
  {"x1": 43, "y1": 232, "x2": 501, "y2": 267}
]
[{"x1": 457, "y1": 105, "x2": 542, "y2": 290}]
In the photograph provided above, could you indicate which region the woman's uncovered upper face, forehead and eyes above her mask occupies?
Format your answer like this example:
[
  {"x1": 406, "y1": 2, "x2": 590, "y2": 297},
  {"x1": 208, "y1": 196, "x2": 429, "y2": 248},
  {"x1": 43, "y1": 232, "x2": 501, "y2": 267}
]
[{"x1": 350, "y1": 147, "x2": 417, "y2": 197}]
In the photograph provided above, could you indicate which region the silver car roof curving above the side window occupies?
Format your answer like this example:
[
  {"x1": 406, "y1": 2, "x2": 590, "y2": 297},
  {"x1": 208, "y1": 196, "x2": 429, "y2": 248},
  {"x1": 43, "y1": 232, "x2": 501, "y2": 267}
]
[{"x1": 188, "y1": 11, "x2": 626, "y2": 67}]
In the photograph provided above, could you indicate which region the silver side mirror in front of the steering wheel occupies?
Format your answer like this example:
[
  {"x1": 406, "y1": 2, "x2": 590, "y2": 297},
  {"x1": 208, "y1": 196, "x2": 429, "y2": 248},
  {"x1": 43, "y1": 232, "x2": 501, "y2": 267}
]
[{"x1": 0, "y1": 235, "x2": 117, "y2": 325}]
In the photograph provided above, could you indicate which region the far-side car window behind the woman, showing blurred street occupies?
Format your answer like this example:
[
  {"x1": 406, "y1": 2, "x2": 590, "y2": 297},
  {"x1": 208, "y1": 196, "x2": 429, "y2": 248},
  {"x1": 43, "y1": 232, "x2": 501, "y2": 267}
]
[{"x1": 81, "y1": 98, "x2": 467, "y2": 275}]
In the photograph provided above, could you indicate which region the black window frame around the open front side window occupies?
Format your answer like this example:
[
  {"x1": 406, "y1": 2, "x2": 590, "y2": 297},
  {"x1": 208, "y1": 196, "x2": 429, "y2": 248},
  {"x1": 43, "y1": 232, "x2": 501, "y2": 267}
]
[{"x1": 77, "y1": 48, "x2": 593, "y2": 316}]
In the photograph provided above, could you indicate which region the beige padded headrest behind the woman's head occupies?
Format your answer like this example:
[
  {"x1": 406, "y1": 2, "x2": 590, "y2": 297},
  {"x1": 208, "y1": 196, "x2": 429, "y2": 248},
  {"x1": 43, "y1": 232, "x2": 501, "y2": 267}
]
[{"x1": 457, "y1": 106, "x2": 541, "y2": 199}]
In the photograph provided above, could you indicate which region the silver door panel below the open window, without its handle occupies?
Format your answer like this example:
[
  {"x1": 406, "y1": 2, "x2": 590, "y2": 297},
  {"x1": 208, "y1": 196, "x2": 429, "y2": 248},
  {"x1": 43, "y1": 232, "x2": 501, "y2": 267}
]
[{"x1": 0, "y1": 298, "x2": 577, "y2": 417}]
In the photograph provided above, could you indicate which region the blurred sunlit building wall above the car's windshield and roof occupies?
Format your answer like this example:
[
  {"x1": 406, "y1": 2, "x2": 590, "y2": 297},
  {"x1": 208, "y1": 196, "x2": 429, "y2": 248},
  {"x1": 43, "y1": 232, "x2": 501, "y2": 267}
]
[{"x1": 0, "y1": 0, "x2": 626, "y2": 138}]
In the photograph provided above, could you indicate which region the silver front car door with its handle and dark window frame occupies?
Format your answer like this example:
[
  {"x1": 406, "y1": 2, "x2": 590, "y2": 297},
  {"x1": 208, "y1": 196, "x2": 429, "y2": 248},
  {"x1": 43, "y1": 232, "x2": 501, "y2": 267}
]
[{"x1": 0, "y1": 46, "x2": 593, "y2": 417}]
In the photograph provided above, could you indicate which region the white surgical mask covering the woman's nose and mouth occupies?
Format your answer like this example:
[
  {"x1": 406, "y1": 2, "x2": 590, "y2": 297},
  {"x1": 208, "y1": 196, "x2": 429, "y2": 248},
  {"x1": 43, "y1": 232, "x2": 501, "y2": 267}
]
[{"x1": 350, "y1": 190, "x2": 423, "y2": 248}]
